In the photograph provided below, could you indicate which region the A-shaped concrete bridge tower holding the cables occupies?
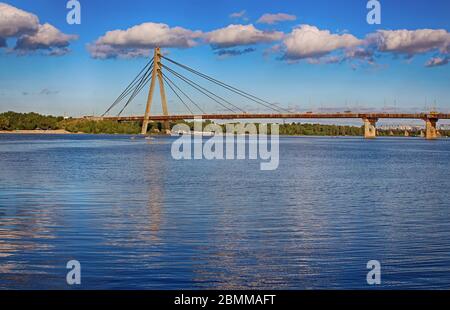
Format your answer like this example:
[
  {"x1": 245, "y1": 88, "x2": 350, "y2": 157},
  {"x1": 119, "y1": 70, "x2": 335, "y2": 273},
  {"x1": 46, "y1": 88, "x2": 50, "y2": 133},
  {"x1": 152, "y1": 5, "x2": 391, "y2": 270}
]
[{"x1": 141, "y1": 47, "x2": 170, "y2": 135}]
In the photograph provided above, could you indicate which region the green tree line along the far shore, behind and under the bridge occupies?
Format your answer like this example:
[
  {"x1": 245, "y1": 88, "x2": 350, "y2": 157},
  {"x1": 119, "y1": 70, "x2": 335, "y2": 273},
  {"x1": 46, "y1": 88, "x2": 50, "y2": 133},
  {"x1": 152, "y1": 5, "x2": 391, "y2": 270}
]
[{"x1": 0, "y1": 112, "x2": 450, "y2": 137}]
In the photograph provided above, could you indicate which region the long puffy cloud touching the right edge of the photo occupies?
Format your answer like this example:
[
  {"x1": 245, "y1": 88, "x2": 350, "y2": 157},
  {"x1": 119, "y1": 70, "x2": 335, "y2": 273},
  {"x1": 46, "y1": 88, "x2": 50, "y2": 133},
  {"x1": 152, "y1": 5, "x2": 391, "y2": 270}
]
[{"x1": 367, "y1": 29, "x2": 450, "y2": 56}]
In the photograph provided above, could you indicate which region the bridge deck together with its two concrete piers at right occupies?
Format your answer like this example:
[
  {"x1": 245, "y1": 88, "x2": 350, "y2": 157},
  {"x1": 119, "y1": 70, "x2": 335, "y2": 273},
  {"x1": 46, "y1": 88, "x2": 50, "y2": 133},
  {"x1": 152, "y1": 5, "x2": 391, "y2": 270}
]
[{"x1": 84, "y1": 113, "x2": 450, "y2": 140}]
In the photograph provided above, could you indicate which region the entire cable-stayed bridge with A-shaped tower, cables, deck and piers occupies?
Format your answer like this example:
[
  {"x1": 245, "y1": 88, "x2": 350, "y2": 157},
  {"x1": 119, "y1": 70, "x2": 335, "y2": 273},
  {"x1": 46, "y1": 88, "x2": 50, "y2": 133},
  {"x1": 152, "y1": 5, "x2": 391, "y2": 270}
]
[{"x1": 90, "y1": 48, "x2": 450, "y2": 140}]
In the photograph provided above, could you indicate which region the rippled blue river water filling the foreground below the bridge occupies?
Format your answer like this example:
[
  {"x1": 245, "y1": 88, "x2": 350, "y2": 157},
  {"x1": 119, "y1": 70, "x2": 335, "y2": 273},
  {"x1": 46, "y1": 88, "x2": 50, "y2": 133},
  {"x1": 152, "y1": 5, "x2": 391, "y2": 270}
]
[{"x1": 0, "y1": 135, "x2": 450, "y2": 289}]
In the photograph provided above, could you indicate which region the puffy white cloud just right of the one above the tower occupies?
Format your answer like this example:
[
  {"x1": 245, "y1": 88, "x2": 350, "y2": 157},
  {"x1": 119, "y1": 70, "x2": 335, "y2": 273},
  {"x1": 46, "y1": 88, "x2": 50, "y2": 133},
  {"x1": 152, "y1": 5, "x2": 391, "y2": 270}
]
[{"x1": 204, "y1": 24, "x2": 284, "y2": 49}]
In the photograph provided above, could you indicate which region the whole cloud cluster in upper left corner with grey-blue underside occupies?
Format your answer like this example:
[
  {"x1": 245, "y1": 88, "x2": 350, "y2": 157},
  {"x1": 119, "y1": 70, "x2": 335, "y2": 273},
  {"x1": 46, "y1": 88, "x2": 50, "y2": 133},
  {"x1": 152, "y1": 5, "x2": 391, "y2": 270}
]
[{"x1": 0, "y1": 3, "x2": 78, "y2": 56}]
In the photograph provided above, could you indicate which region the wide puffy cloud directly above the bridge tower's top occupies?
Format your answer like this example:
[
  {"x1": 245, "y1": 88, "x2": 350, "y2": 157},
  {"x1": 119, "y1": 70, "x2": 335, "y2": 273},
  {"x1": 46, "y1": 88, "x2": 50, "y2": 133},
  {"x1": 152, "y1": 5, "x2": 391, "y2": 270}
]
[{"x1": 88, "y1": 23, "x2": 202, "y2": 58}]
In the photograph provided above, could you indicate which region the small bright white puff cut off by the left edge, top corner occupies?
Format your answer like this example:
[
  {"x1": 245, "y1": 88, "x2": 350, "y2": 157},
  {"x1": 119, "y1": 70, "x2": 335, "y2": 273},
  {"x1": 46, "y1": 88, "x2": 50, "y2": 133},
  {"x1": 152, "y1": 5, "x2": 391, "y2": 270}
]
[{"x1": 0, "y1": 3, "x2": 39, "y2": 39}]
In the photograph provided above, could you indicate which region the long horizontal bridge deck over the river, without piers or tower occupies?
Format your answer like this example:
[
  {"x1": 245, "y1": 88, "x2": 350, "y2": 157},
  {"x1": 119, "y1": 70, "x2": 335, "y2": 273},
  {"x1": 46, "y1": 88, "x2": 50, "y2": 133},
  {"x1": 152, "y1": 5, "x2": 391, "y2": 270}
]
[{"x1": 84, "y1": 113, "x2": 450, "y2": 122}]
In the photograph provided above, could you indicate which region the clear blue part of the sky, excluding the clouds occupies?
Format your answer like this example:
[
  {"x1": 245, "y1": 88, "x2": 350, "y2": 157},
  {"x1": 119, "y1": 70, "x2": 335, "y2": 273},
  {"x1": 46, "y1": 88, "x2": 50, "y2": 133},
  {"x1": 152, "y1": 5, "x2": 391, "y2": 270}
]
[{"x1": 0, "y1": 0, "x2": 450, "y2": 116}]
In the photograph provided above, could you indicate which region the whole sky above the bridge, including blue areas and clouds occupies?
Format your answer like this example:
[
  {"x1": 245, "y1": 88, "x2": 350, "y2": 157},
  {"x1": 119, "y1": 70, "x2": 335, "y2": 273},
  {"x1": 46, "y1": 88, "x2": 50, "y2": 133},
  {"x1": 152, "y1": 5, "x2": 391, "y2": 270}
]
[{"x1": 0, "y1": 0, "x2": 450, "y2": 116}]
